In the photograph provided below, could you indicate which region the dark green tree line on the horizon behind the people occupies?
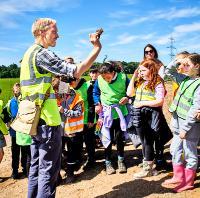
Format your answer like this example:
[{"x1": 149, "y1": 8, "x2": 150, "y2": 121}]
[{"x1": 0, "y1": 61, "x2": 139, "y2": 78}]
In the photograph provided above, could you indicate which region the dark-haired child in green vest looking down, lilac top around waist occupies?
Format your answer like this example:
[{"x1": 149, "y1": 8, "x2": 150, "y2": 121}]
[{"x1": 93, "y1": 62, "x2": 129, "y2": 175}]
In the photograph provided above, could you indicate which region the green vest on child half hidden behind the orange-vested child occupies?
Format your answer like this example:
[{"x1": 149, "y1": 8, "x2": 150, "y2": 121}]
[{"x1": 76, "y1": 82, "x2": 89, "y2": 124}]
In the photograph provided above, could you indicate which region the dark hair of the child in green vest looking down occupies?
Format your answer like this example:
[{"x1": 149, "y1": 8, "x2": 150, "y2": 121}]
[{"x1": 99, "y1": 61, "x2": 122, "y2": 74}]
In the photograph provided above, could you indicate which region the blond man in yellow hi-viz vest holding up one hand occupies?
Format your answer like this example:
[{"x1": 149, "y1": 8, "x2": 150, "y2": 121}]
[{"x1": 20, "y1": 18, "x2": 101, "y2": 198}]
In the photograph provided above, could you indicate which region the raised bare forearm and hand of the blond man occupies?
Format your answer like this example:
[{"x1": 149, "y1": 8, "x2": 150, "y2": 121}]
[{"x1": 74, "y1": 33, "x2": 101, "y2": 78}]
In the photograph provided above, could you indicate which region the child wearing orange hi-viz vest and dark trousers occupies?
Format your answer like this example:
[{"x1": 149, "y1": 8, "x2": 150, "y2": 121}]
[{"x1": 60, "y1": 84, "x2": 84, "y2": 183}]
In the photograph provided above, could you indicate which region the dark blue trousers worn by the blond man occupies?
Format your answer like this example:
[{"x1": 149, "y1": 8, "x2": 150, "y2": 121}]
[{"x1": 28, "y1": 125, "x2": 62, "y2": 198}]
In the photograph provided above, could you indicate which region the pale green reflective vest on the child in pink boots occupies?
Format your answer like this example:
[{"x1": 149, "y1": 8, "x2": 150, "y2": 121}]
[{"x1": 169, "y1": 77, "x2": 200, "y2": 119}]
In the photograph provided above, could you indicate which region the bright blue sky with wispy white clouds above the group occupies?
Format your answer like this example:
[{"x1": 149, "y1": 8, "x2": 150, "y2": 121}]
[{"x1": 0, "y1": 0, "x2": 200, "y2": 65}]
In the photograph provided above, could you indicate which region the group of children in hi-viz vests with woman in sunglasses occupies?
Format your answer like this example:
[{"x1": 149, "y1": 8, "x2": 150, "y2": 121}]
[{"x1": 0, "y1": 47, "x2": 200, "y2": 192}]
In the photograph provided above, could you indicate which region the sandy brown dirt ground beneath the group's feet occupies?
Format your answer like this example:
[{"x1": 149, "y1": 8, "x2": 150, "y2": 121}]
[{"x1": 0, "y1": 81, "x2": 200, "y2": 198}]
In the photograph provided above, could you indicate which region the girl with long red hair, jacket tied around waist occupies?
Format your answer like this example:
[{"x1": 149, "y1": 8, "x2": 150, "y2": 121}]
[{"x1": 127, "y1": 59, "x2": 168, "y2": 178}]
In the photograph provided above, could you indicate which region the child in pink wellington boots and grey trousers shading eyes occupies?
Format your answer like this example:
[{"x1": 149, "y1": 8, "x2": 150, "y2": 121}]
[{"x1": 165, "y1": 54, "x2": 200, "y2": 192}]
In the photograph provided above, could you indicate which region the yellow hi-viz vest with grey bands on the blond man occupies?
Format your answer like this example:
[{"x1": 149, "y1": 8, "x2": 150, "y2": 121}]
[{"x1": 20, "y1": 44, "x2": 61, "y2": 126}]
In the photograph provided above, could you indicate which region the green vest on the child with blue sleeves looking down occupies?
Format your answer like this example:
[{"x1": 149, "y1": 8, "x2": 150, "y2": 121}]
[{"x1": 98, "y1": 73, "x2": 128, "y2": 119}]
